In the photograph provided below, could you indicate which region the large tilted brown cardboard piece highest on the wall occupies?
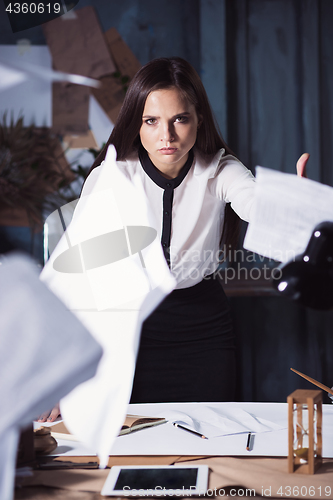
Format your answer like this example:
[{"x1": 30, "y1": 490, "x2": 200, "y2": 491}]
[{"x1": 43, "y1": 6, "x2": 116, "y2": 78}]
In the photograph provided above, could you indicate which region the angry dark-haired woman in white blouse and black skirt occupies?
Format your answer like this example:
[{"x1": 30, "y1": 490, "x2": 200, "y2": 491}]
[{"x1": 40, "y1": 57, "x2": 308, "y2": 421}]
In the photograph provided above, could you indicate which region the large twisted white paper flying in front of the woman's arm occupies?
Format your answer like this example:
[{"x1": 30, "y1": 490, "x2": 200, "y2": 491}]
[{"x1": 41, "y1": 146, "x2": 175, "y2": 466}]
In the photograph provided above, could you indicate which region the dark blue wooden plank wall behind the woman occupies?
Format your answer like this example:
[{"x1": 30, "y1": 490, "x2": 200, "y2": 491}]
[{"x1": 0, "y1": 0, "x2": 333, "y2": 402}]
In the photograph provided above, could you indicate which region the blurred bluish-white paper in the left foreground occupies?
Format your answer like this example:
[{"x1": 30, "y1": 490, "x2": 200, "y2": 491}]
[{"x1": 0, "y1": 253, "x2": 102, "y2": 500}]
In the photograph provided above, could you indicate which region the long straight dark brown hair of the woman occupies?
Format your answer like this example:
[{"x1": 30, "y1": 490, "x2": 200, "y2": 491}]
[{"x1": 91, "y1": 57, "x2": 240, "y2": 252}]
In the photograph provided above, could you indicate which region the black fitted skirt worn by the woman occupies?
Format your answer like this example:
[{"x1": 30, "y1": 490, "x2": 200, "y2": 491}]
[{"x1": 131, "y1": 275, "x2": 235, "y2": 403}]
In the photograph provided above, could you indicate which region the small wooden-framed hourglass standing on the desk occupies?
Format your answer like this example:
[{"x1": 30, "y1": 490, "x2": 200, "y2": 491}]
[{"x1": 287, "y1": 389, "x2": 322, "y2": 474}]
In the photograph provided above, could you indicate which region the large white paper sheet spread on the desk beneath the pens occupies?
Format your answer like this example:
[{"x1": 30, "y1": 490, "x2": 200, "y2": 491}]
[{"x1": 112, "y1": 403, "x2": 287, "y2": 456}]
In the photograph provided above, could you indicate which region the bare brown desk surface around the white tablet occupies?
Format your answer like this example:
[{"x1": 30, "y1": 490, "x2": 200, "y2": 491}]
[{"x1": 15, "y1": 456, "x2": 333, "y2": 500}]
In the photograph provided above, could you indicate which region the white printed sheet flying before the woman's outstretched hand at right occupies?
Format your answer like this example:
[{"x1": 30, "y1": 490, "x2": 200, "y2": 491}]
[{"x1": 244, "y1": 167, "x2": 333, "y2": 262}]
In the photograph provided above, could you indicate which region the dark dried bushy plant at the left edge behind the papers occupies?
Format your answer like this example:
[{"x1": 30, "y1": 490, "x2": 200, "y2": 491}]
[{"x1": 0, "y1": 113, "x2": 74, "y2": 225}]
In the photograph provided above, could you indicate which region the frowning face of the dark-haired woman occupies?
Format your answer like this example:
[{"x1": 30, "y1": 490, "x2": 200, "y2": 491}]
[{"x1": 140, "y1": 88, "x2": 199, "y2": 179}]
